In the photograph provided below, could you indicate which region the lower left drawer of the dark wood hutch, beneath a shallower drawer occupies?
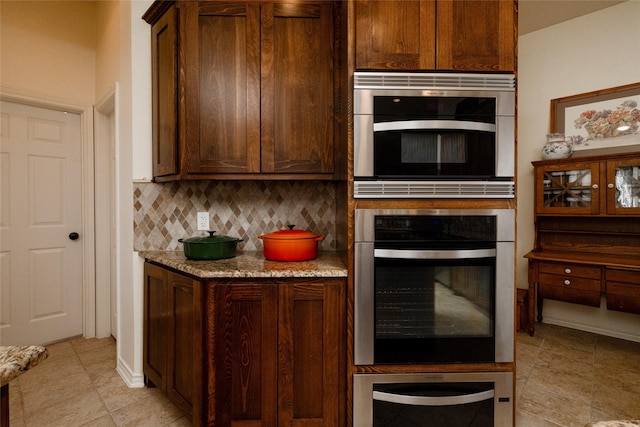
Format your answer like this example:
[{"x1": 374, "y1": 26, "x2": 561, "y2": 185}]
[{"x1": 538, "y1": 273, "x2": 600, "y2": 307}]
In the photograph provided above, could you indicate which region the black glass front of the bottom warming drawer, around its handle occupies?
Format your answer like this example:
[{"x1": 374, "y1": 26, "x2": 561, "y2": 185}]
[{"x1": 373, "y1": 383, "x2": 494, "y2": 427}]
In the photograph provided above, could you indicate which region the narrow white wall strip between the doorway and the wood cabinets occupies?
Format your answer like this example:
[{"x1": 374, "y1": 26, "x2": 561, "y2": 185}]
[{"x1": 116, "y1": 0, "x2": 152, "y2": 387}]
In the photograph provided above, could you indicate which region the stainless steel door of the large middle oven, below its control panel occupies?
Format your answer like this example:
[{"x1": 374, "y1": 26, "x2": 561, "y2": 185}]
[{"x1": 354, "y1": 242, "x2": 514, "y2": 365}]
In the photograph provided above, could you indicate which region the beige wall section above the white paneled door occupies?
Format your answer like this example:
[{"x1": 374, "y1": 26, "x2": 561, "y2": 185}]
[{"x1": 0, "y1": 0, "x2": 96, "y2": 106}]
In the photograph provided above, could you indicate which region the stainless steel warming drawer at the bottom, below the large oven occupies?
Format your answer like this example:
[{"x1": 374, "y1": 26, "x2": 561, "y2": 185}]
[{"x1": 353, "y1": 372, "x2": 513, "y2": 427}]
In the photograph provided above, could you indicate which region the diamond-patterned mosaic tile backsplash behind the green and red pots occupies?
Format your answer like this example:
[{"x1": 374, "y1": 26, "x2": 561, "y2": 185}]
[{"x1": 133, "y1": 181, "x2": 336, "y2": 251}]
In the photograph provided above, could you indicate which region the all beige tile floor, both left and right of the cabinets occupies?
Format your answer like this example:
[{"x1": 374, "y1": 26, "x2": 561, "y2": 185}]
[{"x1": 10, "y1": 325, "x2": 640, "y2": 427}]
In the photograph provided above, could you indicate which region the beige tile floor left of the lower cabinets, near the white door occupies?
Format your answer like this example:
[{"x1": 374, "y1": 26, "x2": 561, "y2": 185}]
[{"x1": 9, "y1": 338, "x2": 190, "y2": 427}]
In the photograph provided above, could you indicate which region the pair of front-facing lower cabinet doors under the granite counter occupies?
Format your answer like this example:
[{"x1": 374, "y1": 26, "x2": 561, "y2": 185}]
[{"x1": 212, "y1": 280, "x2": 346, "y2": 427}]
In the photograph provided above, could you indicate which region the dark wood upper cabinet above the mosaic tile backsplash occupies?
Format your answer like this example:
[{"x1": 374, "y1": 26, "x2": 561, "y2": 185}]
[{"x1": 145, "y1": 1, "x2": 346, "y2": 181}]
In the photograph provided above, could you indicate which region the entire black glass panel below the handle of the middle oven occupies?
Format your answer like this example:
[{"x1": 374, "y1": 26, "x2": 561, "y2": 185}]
[{"x1": 374, "y1": 257, "x2": 495, "y2": 363}]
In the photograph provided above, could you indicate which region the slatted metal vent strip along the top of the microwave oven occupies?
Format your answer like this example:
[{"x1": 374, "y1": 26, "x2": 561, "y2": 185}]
[{"x1": 353, "y1": 72, "x2": 516, "y2": 91}]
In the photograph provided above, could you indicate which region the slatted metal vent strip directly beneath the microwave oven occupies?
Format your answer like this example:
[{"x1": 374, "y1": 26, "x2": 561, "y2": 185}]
[{"x1": 353, "y1": 181, "x2": 515, "y2": 199}]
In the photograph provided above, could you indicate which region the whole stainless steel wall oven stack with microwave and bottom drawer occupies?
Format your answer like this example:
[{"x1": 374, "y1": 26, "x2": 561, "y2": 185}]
[{"x1": 353, "y1": 72, "x2": 515, "y2": 427}]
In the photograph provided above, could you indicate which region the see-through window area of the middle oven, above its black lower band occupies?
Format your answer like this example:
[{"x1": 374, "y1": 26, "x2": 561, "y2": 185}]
[{"x1": 375, "y1": 260, "x2": 493, "y2": 339}]
